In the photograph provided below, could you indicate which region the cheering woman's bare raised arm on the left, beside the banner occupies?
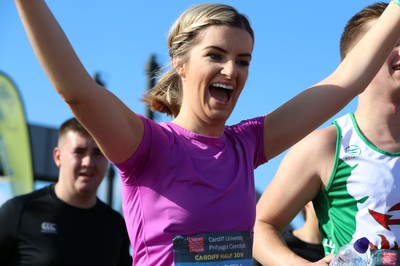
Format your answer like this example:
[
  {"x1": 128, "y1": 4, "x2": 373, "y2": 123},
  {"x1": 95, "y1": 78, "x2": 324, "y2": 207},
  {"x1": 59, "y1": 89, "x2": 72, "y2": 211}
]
[{"x1": 15, "y1": 0, "x2": 143, "y2": 162}]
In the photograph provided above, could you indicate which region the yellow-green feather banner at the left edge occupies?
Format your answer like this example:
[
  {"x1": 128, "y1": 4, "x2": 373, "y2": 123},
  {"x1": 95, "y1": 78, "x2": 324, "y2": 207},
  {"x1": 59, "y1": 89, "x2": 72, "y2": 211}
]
[{"x1": 0, "y1": 72, "x2": 33, "y2": 195}]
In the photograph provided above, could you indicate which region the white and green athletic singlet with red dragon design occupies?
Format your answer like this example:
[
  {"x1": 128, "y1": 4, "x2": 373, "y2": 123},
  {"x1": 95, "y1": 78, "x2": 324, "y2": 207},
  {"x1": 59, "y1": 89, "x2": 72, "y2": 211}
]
[{"x1": 313, "y1": 113, "x2": 400, "y2": 255}]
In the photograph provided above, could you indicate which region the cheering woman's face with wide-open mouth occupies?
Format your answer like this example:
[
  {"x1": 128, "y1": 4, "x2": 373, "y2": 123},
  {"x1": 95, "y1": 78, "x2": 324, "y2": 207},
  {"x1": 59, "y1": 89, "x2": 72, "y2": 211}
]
[{"x1": 177, "y1": 25, "x2": 254, "y2": 128}]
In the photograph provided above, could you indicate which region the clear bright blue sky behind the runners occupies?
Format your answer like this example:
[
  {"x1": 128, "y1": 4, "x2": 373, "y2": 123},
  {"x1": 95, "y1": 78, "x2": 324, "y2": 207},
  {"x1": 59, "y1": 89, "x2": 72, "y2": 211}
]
[{"x1": 0, "y1": 0, "x2": 373, "y2": 224}]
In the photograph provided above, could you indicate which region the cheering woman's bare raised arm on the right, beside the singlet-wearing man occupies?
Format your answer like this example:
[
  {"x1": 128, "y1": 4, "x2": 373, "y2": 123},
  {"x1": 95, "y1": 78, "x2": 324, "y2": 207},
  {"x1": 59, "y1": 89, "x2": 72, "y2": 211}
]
[{"x1": 264, "y1": 1, "x2": 400, "y2": 159}]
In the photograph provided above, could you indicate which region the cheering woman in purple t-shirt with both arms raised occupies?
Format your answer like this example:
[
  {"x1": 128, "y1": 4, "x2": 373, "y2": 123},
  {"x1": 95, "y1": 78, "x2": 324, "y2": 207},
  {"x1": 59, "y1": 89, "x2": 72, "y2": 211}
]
[{"x1": 16, "y1": 0, "x2": 400, "y2": 265}]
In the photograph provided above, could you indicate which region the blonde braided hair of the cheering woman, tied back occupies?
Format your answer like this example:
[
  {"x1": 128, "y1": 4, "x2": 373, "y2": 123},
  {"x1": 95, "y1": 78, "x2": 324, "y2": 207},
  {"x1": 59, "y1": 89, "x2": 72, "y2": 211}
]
[{"x1": 142, "y1": 4, "x2": 254, "y2": 117}]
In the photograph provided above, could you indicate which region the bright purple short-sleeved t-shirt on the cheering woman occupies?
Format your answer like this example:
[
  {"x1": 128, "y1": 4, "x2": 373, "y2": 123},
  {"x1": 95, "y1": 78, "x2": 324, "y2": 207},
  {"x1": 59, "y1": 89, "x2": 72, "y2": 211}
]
[{"x1": 116, "y1": 117, "x2": 266, "y2": 265}]
